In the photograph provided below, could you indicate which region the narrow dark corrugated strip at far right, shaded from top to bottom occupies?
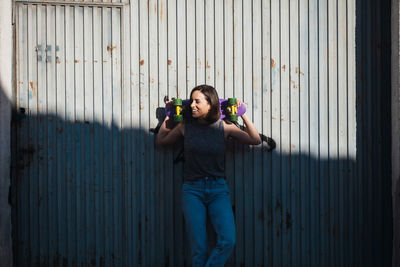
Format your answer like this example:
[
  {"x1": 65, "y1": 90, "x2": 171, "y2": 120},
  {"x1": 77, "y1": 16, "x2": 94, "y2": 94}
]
[{"x1": 357, "y1": 1, "x2": 392, "y2": 266}]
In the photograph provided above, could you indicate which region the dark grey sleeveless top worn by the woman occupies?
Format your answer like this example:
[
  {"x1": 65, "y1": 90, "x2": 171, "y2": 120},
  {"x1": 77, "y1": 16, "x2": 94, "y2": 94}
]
[{"x1": 183, "y1": 119, "x2": 225, "y2": 181}]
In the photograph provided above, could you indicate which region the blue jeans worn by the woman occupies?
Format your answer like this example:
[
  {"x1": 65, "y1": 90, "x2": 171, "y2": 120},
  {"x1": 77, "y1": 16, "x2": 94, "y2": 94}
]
[{"x1": 182, "y1": 178, "x2": 235, "y2": 267}]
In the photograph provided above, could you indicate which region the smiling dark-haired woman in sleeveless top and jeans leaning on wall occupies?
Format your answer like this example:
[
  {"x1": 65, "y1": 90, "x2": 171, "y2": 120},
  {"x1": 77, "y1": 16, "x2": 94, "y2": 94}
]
[{"x1": 156, "y1": 85, "x2": 261, "y2": 267}]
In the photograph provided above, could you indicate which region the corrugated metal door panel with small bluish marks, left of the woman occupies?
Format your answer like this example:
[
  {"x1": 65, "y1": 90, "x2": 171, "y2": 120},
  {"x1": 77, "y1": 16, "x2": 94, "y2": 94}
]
[{"x1": 14, "y1": 3, "x2": 130, "y2": 266}]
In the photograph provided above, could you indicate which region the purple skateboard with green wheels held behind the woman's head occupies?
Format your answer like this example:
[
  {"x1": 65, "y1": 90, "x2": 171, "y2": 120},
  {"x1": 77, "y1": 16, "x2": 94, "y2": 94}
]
[{"x1": 165, "y1": 97, "x2": 246, "y2": 122}]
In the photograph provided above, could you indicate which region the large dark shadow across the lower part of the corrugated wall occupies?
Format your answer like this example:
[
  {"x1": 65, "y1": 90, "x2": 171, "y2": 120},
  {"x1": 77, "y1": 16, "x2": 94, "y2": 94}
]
[{"x1": 10, "y1": 103, "x2": 391, "y2": 266}]
